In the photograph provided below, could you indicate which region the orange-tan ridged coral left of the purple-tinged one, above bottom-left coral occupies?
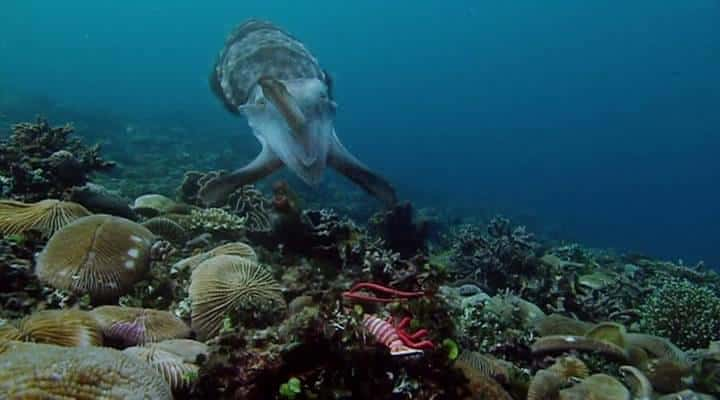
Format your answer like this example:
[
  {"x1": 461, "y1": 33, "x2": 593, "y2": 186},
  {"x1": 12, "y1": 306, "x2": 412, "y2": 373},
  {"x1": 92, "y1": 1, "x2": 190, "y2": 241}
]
[{"x1": 18, "y1": 310, "x2": 102, "y2": 347}]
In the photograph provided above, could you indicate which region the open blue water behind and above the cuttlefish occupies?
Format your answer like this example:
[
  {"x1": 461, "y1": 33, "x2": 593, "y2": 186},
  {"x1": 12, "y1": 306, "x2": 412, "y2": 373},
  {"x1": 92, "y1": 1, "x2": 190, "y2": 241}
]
[{"x1": 0, "y1": 0, "x2": 720, "y2": 266}]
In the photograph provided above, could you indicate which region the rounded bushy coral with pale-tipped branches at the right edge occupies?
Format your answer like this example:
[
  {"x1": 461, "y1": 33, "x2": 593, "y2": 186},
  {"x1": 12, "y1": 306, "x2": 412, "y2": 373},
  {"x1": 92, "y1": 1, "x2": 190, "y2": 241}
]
[{"x1": 640, "y1": 279, "x2": 720, "y2": 349}]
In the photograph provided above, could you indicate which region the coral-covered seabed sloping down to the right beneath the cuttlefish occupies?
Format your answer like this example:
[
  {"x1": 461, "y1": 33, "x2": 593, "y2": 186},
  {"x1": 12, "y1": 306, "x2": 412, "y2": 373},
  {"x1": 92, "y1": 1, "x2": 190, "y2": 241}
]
[{"x1": 0, "y1": 111, "x2": 720, "y2": 400}]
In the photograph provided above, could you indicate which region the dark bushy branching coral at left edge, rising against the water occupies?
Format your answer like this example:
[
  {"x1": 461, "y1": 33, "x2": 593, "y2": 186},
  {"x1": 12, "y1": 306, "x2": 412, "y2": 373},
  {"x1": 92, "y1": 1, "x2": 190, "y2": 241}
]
[{"x1": 0, "y1": 118, "x2": 115, "y2": 200}]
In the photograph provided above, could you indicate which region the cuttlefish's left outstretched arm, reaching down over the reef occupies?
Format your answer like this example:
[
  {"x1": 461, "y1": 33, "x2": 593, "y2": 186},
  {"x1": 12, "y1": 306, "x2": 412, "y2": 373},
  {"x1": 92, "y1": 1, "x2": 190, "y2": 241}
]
[{"x1": 198, "y1": 140, "x2": 283, "y2": 205}]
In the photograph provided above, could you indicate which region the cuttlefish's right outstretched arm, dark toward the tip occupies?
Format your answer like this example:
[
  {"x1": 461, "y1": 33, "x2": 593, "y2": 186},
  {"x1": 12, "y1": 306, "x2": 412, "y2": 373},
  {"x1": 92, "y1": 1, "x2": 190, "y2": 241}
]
[{"x1": 327, "y1": 132, "x2": 397, "y2": 207}]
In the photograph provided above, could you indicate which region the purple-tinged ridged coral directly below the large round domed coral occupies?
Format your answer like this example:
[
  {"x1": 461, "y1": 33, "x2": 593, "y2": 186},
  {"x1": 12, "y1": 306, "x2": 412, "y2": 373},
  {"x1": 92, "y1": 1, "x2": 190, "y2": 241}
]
[{"x1": 91, "y1": 306, "x2": 190, "y2": 346}]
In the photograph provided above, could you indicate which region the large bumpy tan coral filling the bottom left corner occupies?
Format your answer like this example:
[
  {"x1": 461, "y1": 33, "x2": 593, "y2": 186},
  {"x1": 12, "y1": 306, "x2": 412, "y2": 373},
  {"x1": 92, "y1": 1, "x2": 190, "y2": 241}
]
[{"x1": 0, "y1": 342, "x2": 172, "y2": 400}]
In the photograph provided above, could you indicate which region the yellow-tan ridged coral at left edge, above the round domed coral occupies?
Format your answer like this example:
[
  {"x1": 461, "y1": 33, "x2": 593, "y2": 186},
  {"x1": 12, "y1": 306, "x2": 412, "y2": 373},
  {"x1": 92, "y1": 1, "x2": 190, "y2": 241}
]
[{"x1": 0, "y1": 199, "x2": 90, "y2": 236}]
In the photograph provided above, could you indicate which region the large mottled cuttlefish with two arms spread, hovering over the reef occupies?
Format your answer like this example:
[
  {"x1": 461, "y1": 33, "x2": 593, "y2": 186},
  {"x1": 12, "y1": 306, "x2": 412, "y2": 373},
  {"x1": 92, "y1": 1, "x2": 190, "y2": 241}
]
[{"x1": 199, "y1": 20, "x2": 396, "y2": 206}]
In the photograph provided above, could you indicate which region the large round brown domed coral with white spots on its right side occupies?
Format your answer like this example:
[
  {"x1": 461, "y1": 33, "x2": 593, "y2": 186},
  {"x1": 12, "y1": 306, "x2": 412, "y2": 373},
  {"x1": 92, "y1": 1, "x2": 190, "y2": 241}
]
[{"x1": 36, "y1": 214, "x2": 155, "y2": 301}]
